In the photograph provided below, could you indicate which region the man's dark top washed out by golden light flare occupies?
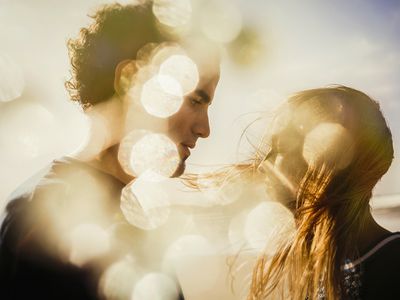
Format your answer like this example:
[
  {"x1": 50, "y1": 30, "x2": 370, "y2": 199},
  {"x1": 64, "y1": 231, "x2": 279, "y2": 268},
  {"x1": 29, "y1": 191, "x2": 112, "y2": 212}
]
[{"x1": 0, "y1": 158, "x2": 183, "y2": 300}]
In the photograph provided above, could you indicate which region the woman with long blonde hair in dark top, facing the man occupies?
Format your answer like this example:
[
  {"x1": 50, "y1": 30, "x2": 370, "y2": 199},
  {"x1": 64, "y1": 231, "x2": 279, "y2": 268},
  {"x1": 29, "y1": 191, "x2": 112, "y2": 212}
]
[{"x1": 241, "y1": 86, "x2": 400, "y2": 300}]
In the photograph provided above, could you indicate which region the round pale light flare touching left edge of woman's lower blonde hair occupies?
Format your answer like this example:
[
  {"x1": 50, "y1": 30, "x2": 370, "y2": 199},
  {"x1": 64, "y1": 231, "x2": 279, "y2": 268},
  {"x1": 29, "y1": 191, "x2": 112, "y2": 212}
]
[{"x1": 244, "y1": 201, "x2": 295, "y2": 254}]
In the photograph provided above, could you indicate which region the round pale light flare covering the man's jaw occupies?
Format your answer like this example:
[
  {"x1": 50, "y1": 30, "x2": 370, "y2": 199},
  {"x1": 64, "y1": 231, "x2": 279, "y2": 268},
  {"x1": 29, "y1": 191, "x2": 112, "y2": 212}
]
[{"x1": 118, "y1": 130, "x2": 180, "y2": 177}]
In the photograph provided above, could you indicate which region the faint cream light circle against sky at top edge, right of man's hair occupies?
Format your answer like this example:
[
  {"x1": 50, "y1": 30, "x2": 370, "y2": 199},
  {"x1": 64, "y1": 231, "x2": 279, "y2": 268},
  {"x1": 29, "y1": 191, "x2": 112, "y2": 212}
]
[{"x1": 201, "y1": 1, "x2": 243, "y2": 43}]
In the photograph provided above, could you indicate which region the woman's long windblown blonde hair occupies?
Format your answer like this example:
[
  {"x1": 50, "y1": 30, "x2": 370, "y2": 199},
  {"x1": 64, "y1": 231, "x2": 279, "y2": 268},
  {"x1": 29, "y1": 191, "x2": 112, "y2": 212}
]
[{"x1": 247, "y1": 86, "x2": 393, "y2": 300}]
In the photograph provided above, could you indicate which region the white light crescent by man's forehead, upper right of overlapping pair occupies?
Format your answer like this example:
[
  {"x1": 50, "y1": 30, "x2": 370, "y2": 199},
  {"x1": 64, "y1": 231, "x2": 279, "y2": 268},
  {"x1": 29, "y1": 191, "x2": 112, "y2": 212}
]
[{"x1": 159, "y1": 55, "x2": 199, "y2": 95}]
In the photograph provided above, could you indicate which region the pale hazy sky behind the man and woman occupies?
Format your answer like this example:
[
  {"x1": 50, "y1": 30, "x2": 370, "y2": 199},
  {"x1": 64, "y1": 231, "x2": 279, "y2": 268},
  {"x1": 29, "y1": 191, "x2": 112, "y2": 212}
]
[{"x1": 0, "y1": 0, "x2": 400, "y2": 221}]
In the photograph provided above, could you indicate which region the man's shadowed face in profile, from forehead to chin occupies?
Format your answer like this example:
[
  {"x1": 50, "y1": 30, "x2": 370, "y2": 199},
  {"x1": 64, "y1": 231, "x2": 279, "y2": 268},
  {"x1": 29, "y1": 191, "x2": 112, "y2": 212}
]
[{"x1": 167, "y1": 70, "x2": 219, "y2": 177}]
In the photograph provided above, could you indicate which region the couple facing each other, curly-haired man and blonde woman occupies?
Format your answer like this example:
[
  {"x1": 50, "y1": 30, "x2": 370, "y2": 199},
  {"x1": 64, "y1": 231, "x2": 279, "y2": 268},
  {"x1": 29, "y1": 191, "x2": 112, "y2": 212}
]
[{"x1": 0, "y1": 4, "x2": 400, "y2": 299}]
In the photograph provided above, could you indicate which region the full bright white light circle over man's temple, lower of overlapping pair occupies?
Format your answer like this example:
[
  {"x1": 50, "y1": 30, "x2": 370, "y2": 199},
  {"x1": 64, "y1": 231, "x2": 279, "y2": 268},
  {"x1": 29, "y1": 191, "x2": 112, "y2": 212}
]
[{"x1": 140, "y1": 74, "x2": 183, "y2": 118}]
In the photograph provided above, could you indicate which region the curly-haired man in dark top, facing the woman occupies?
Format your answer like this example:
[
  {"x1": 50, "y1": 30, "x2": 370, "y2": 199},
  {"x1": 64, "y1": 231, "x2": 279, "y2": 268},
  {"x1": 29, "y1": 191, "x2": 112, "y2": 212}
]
[{"x1": 0, "y1": 3, "x2": 219, "y2": 299}]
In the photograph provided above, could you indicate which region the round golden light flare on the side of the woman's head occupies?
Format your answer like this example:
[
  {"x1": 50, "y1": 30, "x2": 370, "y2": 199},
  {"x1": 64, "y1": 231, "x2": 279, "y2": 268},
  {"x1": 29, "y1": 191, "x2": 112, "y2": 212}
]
[{"x1": 303, "y1": 123, "x2": 354, "y2": 170}]
